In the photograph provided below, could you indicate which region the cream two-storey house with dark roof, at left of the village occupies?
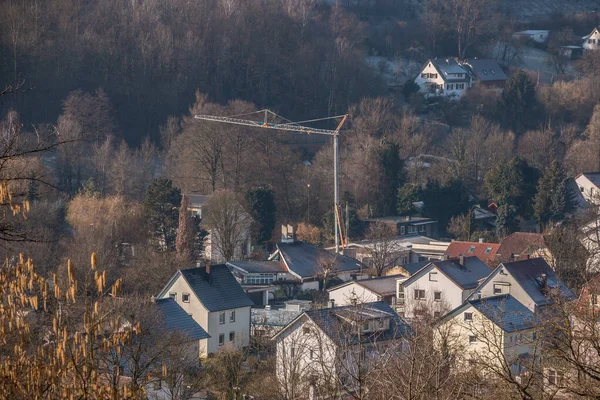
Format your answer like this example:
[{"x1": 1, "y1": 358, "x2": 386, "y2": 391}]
[{"x1": 157, "y1": 265, "x2": 254, "y2": 357}]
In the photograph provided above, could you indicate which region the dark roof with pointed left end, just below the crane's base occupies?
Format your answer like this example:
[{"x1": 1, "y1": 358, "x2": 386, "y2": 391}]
[{"x1": 277, "y1": 242, "x2": 367, "y2": 278}]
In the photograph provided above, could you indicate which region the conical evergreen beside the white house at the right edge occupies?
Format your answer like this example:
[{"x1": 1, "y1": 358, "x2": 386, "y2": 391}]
[{"x1": 534, "y1": 161, "x2": 575, "y2": 224}]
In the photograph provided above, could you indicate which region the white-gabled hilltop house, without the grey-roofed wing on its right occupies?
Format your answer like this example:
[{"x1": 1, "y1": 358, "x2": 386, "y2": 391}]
[{"x1": 415, "y1": 58, "x2": 471, "y2": 99}]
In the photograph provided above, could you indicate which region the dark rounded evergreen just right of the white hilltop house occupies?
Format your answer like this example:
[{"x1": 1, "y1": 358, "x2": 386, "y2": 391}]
[{"x1": 500, "y1": 71, "x2": 538, "y2": 132}]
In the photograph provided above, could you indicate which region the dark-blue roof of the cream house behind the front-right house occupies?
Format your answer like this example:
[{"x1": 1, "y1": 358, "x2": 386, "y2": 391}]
[{"x1": 498, "y1": 258, "x2": 575, "y2": 306}]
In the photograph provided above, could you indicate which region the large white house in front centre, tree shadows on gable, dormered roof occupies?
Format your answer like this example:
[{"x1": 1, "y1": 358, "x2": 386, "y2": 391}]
[{"x1": 273, "y1": 302, "x2": 411, "y2": 398}]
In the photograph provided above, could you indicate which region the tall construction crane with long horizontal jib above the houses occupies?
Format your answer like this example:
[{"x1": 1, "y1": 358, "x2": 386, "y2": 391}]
[{"x1": 194, "y1": 110, "x2": 348, "y2": 253}]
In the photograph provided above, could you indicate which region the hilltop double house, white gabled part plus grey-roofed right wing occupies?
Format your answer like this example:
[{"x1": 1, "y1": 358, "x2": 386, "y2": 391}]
[{"x1": 415, "y1": 58, "x2": 508, "y2": 99}]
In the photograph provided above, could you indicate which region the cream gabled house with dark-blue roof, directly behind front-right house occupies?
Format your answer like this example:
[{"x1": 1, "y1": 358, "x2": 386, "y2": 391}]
[{"x1": 469, "y1": 257, "x2": 575, "y2": 313}]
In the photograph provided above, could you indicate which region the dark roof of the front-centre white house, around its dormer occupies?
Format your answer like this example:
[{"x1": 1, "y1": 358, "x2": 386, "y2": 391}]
[{"x1": 304, "y1": 301, "x2": 411, "y2": 346}]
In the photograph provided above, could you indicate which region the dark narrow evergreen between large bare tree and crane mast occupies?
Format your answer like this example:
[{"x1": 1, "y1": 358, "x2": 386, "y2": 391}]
[{"x1": 246, "y1": 186, "x2": 277, "y2": 244}]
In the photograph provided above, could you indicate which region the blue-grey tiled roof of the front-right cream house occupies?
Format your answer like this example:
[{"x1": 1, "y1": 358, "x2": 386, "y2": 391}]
[{"x1": 468, "y1": 294, "x2": 536, "y2": 332}]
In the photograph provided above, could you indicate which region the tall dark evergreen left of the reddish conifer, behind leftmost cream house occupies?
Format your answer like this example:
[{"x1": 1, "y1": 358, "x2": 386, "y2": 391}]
[{"x1": 143, "y1": 178, "x2": 181, "y2": 250}]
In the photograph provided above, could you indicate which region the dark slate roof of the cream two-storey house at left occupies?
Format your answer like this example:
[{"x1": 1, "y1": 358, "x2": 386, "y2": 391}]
[{"x1": 171, "y1": 264, "x2": 254, "y2": 311}]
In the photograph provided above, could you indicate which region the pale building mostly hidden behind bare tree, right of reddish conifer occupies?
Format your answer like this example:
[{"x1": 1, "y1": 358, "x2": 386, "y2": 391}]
[{"x1": 185, "y1": 194, "x2": 252, "y2": 263}]
